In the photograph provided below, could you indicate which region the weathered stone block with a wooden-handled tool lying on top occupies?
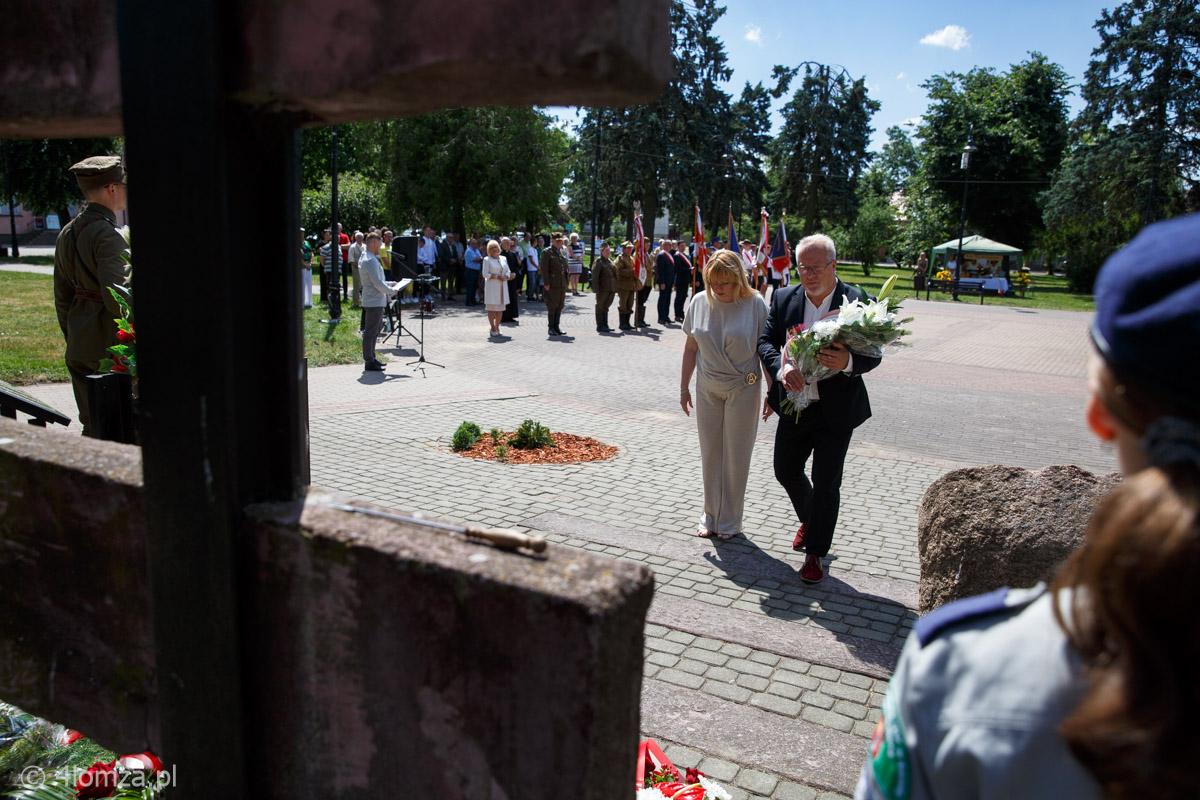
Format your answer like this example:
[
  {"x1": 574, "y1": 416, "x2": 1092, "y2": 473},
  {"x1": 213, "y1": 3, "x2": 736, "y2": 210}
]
[{"x1": 246, "y1": 493, "x2": 653, "y2": 800}]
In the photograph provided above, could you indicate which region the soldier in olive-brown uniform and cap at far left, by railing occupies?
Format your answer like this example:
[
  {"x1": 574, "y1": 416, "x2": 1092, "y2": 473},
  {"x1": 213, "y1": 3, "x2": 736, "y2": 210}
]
[{"x1": 54, "y1": 156, "x2": 131, "y2": 437}]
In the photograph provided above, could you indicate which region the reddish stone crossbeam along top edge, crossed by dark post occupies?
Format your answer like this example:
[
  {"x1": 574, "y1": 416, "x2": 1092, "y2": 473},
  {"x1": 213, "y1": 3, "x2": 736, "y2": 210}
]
[{"x1": 0, "y1": 0, "x2": 673, "y2": 137}]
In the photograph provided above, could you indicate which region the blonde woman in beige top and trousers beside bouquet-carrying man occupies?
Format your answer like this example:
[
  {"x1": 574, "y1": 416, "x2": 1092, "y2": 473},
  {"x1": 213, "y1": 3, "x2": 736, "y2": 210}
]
[{"x1": 679, "y1": 249, "x2": 767, "y2": 539}]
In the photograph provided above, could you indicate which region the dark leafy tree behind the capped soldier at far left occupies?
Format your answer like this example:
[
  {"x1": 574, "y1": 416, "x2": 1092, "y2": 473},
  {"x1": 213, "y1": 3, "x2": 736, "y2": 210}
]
[{"x1": 0, "y1": 138, "x2": 121, "y2": 224}]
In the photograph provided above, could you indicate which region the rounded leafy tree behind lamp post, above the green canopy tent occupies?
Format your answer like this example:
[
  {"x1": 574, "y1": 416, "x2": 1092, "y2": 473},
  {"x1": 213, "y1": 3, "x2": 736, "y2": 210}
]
[{"x1": 918, "y1": 53, "x2": 1069, "y2": 248}]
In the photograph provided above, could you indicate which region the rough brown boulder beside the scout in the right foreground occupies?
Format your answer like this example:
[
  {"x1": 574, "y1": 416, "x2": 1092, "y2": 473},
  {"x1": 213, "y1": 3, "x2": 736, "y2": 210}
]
[{"x1": 917, "y1": 467, "x2": 1121, "y2": 613}]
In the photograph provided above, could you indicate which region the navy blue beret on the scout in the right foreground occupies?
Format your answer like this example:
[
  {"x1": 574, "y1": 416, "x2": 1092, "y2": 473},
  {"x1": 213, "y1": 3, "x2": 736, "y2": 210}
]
[{"x1": 1092, "y1": 213, "x2": 1200, "y2": 408}]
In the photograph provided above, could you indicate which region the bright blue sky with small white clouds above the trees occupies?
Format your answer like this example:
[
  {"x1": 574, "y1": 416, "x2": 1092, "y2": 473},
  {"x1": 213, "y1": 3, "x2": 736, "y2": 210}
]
[{"x1": 556, "y1": 0, "x2": 1116, "y2": 150}]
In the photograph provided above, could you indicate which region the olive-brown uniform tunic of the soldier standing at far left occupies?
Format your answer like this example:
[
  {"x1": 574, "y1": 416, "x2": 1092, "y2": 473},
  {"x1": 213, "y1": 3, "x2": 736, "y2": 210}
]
[{"x1": 54, "y1": 203, "x2": 131, "y2": 361}]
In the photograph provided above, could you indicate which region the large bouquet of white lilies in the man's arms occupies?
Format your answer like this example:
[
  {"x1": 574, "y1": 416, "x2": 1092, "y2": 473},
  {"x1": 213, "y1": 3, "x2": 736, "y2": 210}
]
[{"x1": 782, "y1": 275, "x2": 912, "y2": 419}]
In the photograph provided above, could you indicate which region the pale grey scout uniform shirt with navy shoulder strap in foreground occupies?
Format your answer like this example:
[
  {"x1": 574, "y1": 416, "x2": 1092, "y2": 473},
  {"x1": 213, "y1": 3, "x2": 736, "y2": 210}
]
[{"x1": 854, "y1": 585, "x2": 1103, "y2": 800}]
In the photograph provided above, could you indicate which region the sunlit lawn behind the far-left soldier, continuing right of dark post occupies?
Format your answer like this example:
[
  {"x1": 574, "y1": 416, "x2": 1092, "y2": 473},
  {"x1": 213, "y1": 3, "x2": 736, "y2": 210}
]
[{"x1": 0, "y1": 271, "x2": 364, "y2": 385}]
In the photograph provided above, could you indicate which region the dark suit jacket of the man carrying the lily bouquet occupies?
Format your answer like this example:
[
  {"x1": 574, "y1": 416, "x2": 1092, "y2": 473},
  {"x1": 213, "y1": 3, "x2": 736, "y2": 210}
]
[{"x1": 758, "y1": 278, "x2": 882, "y2": 431}]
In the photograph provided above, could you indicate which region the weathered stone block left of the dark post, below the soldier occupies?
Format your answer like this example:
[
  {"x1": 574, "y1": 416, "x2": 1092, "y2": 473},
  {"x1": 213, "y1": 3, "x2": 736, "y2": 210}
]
[{"x1": 0, "y1": 419, "x2": 158, "y2": 753}]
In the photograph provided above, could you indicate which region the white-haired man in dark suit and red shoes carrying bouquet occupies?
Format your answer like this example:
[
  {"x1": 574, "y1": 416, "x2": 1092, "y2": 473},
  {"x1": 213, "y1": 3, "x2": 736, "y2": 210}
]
[{"x1": 758, "y1": 234, "x2": 880, "y2": 583}]
